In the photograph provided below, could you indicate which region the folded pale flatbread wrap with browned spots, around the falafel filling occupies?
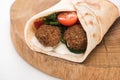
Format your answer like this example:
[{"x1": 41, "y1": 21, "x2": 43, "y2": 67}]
[{"x1": 24, "y1": 0, "x2": 119, "y2": 63}]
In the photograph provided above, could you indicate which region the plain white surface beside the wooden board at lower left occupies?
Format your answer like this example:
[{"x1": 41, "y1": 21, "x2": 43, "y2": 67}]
[{"x1": 0, "y1": 0, "x2": 58, "y2": 80}]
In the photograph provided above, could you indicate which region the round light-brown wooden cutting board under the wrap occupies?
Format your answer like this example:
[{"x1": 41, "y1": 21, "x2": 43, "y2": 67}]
[{"x1": 11, "y1": 0, "x2": 120, "y2": 80}]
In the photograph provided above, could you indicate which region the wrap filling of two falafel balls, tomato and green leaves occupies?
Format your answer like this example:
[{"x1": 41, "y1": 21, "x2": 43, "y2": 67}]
[{"x1": 33, "y1": 11, "x2": 87, "y2": 54}]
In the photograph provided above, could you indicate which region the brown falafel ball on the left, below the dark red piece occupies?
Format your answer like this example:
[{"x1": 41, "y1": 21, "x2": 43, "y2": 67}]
[{"x1": 35, "y1": 25, "x2": 61, "y2": 47}]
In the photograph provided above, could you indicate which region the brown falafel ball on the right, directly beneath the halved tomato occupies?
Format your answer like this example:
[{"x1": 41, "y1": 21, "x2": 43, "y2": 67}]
[{"x1": 64, "y1": 24, "x2": 87, "y2": 50}]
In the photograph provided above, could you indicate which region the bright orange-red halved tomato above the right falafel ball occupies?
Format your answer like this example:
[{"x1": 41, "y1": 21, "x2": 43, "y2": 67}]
[{"x1": 57, "y1": 12, "x2": 78, "y2": 27}]
